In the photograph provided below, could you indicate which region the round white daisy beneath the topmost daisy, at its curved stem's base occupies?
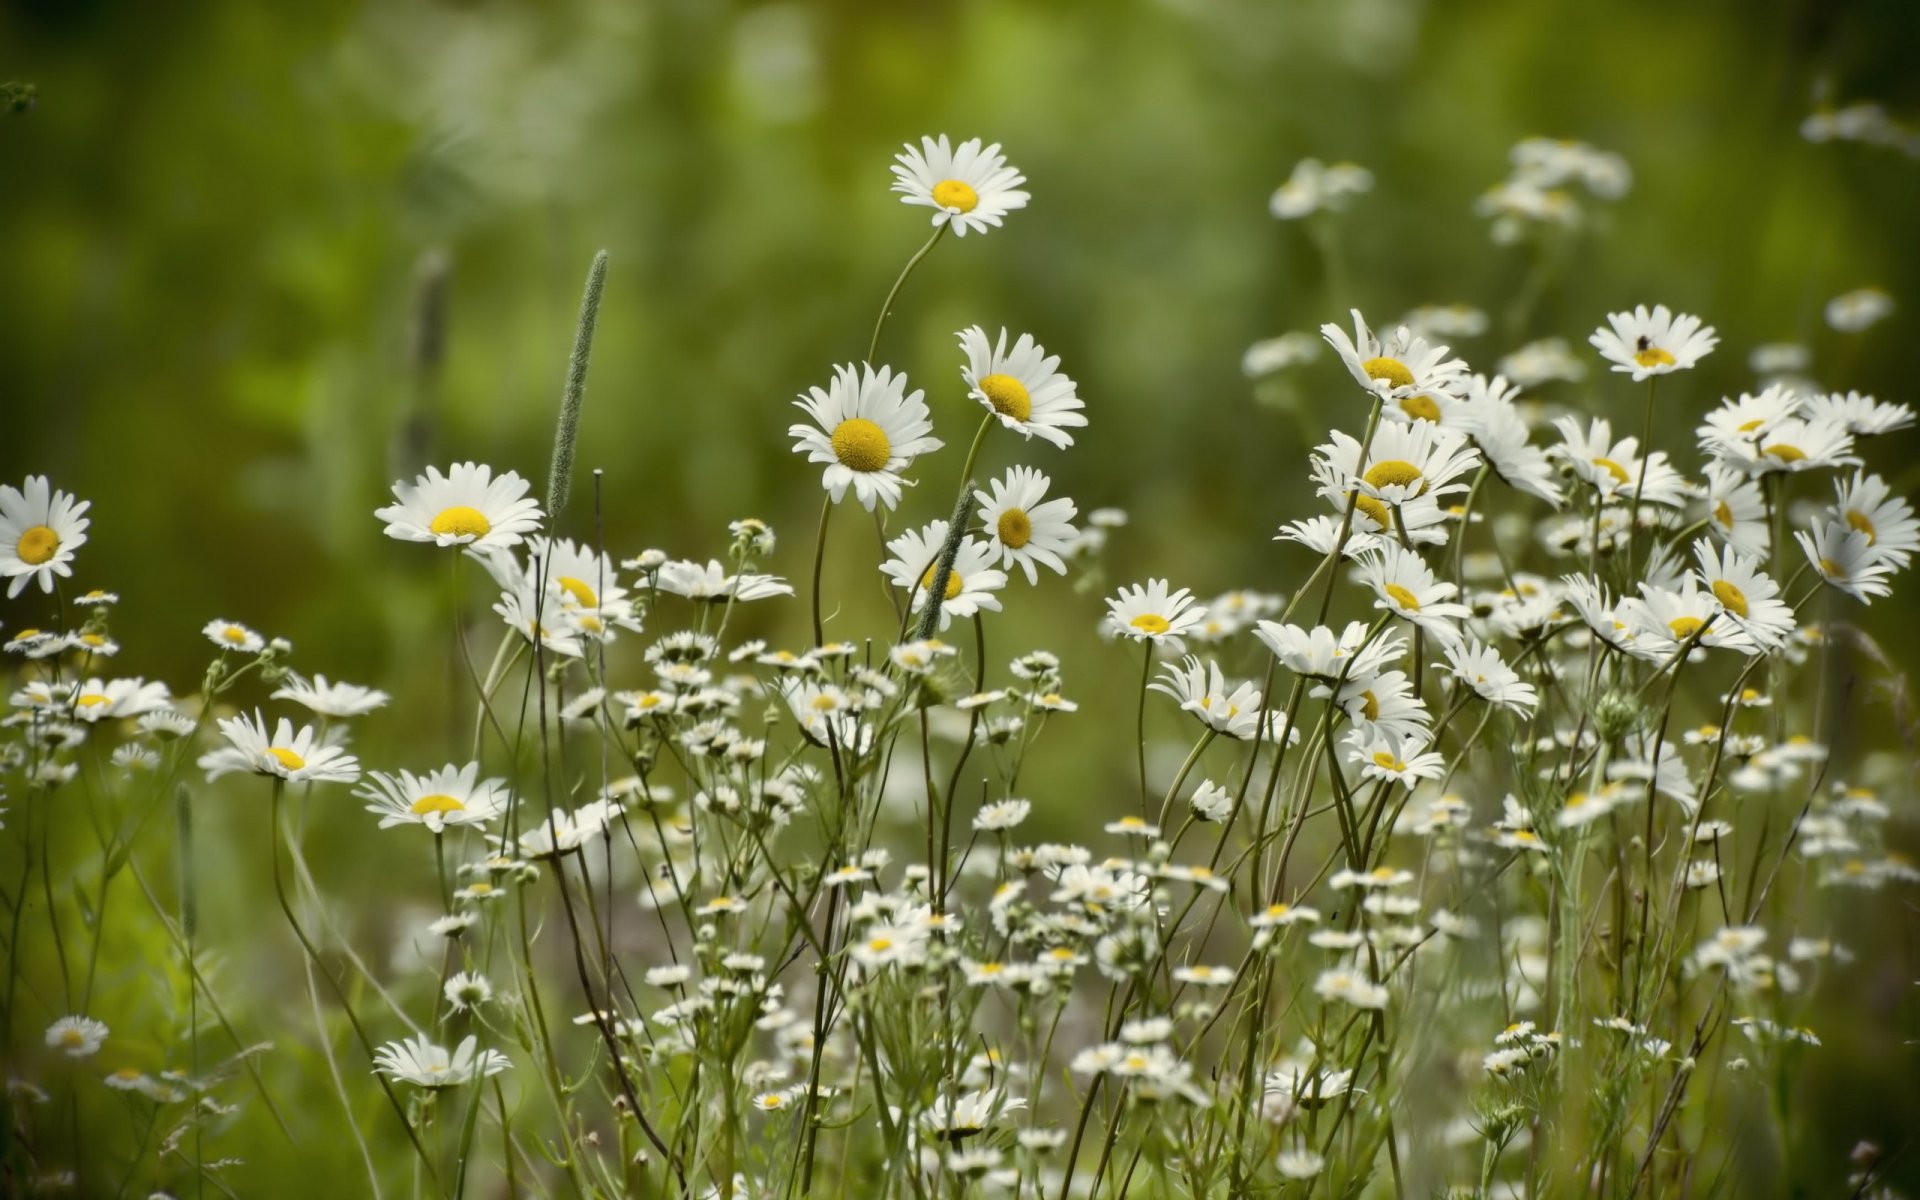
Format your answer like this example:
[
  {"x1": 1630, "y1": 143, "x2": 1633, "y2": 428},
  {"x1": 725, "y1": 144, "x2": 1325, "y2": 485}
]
[{"x1": 787, "y1": 355, "x2": 941, "y2": 511}]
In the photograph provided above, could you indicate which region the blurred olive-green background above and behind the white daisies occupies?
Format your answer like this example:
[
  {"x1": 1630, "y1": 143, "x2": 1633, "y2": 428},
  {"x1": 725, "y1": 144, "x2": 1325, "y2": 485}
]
[{"x1": 0, "y1": 0, "x2": 1920, "y2": 1182}]
